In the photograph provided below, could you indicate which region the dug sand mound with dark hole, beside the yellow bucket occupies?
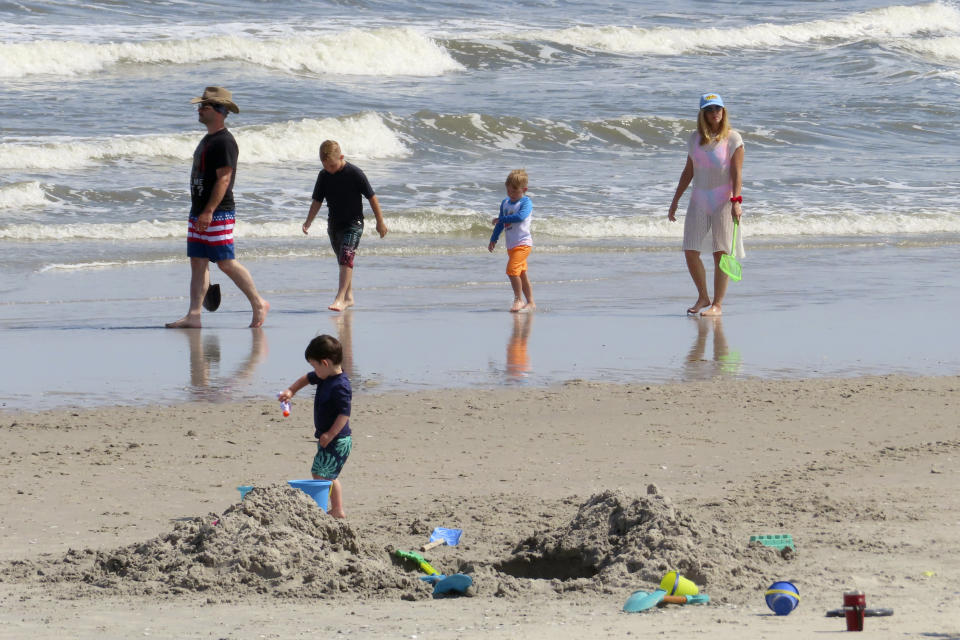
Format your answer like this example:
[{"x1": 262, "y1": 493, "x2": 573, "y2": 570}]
[{"x1": 480, "y1": 485, "x2": 792, "y2": 600}]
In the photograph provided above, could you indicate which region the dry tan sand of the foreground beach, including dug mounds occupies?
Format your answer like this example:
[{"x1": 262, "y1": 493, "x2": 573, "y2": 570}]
[{"x1": 0, "y1": 377, "x2": 960, "y2": 639}]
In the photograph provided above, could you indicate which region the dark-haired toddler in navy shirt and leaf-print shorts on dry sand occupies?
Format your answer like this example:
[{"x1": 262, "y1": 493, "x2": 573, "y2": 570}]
[{"x1": 277, "y1": 335, "x2": 353, "y2": 518}]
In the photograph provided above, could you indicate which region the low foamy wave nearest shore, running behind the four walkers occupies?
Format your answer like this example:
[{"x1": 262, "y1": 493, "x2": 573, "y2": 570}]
[{"x1": 0, "y1": 210, "x2": 960, "y2": 244}]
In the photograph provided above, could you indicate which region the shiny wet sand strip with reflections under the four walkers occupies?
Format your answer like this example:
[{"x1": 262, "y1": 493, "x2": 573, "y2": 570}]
[{"x1": 0, "y1": 240, "x2": 960, "y2": 410}]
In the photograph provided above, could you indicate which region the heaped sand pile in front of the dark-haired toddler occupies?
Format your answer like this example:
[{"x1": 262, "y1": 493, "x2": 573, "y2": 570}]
[{"x1": 3, "y1": 485, "x2": 429, "y2": 601}]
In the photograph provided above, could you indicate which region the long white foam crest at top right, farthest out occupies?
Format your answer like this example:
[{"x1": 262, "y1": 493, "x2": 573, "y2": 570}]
[{"x1": 519, "y1": 3, "x2": 960, "y2": 55}]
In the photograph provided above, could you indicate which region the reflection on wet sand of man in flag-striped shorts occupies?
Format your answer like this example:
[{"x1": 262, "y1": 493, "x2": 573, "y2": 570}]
[{"x1": 180, "y1": 329, "x2": 267, "y2": 402}]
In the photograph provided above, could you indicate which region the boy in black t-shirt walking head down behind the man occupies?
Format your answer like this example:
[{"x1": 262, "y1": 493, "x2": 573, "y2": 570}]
[{"x1": 303, "y1": 140, "x2": 387, "y2": 311}]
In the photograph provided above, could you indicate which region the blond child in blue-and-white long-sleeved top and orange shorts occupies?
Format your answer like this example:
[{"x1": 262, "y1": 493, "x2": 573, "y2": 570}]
[{"x1": 487, "y1": 169, "x2": 537, "y2": 313}]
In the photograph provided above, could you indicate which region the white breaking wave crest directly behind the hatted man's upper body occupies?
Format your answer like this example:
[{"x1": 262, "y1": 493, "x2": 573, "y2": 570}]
[{"x1": 0, "y1": 113, "x2": 409, "y2": 169}]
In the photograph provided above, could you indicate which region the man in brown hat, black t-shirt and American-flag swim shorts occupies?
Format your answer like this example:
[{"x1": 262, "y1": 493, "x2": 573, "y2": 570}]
[{"x1": 167, "y1": 87, "x2": 270, "y2": 329}]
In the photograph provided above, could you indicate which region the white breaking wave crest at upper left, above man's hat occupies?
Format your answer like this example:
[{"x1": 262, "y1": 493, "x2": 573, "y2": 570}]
[{"x1": 0, "y1": 28, "x2": 462, "y2": 79}]
